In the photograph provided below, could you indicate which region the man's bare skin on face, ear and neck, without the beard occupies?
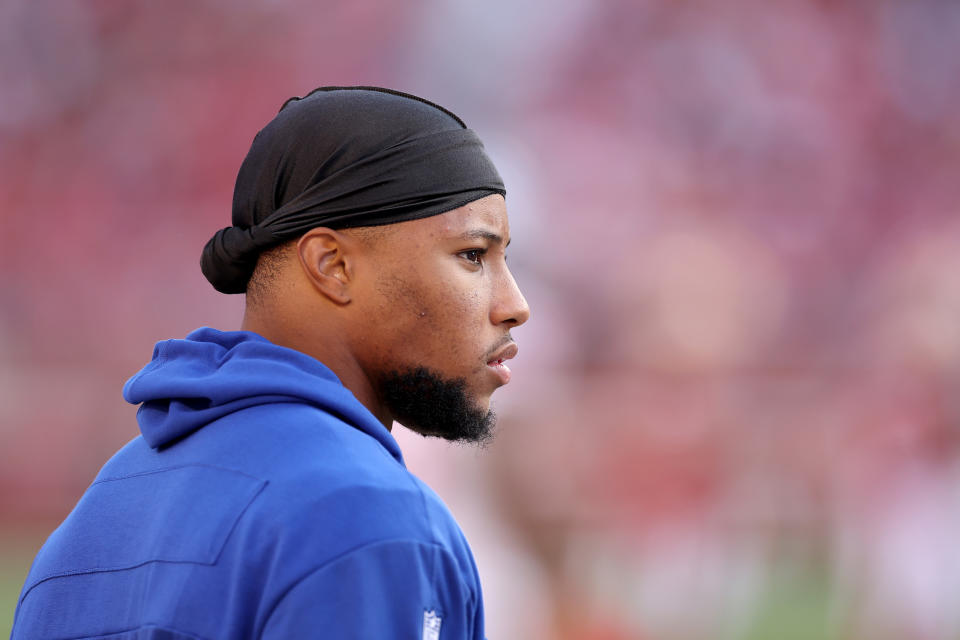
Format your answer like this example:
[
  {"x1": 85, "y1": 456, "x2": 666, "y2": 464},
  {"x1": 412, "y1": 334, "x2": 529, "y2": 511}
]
[{"x1": 242, "y1": 195, "x2": 530, "y2": 439}]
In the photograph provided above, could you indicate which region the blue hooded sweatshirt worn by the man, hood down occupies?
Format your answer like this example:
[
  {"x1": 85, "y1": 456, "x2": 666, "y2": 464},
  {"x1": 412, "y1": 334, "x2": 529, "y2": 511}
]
[{"x1": 11, "y1": 328, "x2": 483, "y2": 640}]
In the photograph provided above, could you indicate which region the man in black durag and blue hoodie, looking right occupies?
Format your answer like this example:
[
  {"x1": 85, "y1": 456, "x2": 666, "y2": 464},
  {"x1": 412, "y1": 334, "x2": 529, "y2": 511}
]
[{"x1": 12, "y1": 87, "x2": 529, "y2": 640}]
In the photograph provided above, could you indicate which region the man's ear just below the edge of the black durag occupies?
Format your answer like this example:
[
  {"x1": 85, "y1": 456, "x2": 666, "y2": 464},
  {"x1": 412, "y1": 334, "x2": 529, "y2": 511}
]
[{"x1": 297, "y1": 227, "x2": 354, "y2": 304}]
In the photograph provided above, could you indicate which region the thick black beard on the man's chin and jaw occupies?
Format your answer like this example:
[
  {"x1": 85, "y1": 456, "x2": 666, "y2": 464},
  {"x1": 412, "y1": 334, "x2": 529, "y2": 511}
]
[{"x1": 378, "y1": 367, "x2": 496, "y2": 446}]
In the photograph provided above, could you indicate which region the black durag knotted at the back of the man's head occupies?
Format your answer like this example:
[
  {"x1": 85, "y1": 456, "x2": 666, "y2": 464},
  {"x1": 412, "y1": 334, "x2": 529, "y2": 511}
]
[{"x1": 200, "y1": 87, "x2": 506, "y2": 293}]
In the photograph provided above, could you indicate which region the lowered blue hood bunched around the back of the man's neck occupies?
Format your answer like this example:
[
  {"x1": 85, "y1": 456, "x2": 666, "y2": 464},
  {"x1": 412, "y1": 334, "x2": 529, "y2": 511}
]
[{"x1": 123, "y1": 327, "x2": 403, "y2": 464}]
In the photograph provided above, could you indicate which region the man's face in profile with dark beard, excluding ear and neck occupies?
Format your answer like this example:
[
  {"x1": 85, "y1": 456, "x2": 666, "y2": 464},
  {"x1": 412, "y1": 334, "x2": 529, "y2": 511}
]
[{"x1": 355, "y1": 195, "x2": 530, "y2": 440}]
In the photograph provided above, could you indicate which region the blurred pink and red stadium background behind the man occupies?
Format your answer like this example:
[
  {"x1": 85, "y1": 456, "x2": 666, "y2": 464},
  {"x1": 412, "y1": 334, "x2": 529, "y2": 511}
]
[{"x1": 0, "y1": 0, "x2": 960, "y2": 640}]
